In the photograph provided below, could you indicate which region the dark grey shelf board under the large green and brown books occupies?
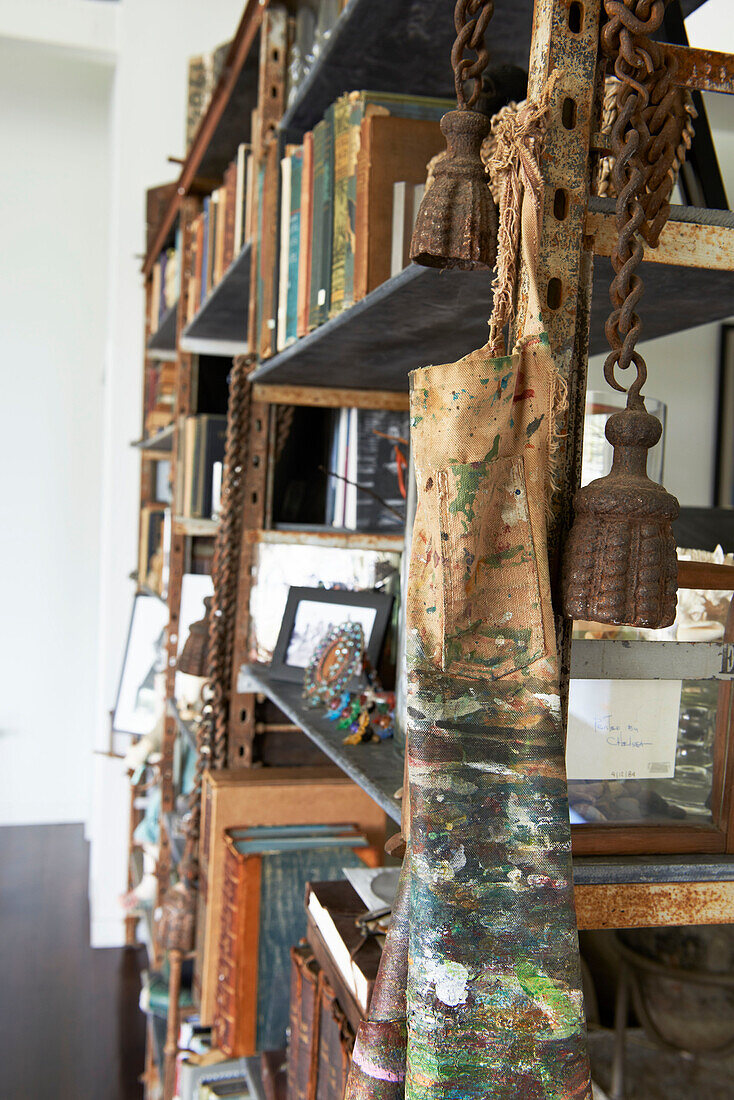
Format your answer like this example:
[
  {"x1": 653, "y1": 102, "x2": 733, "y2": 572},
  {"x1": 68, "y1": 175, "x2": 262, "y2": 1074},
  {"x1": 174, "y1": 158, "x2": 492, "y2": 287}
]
[{"x1": 252, "y1": 202, "x2": 734, "y2": 391}]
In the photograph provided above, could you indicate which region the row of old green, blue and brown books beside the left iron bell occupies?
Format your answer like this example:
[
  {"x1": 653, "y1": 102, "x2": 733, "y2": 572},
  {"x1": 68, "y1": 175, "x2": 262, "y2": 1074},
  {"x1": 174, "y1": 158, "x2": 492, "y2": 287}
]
[{"x1": 264, "y1": 91, "x2": 452, "y2": 351}]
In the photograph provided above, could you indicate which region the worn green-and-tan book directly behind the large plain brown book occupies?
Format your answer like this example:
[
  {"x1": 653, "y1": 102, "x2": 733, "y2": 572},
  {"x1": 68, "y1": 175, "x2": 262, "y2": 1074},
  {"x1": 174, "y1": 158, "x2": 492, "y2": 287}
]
[{"x1": 329, "y1": 91, "x2": 456, "y2": 317}]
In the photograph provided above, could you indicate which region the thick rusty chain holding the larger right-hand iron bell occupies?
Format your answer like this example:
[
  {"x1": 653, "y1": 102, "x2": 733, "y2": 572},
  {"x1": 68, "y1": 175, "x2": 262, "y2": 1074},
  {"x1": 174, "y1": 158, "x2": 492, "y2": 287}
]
[{"x1": 602, "y1": 0, "x2": 669, "y2": 405}]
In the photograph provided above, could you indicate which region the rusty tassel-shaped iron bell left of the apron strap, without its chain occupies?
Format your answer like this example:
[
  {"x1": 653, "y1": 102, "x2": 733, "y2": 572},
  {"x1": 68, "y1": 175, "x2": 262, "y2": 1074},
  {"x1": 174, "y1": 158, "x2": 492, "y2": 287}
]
[{"x1": 410, "y1": 110, "x2": 497, "y2": 271}]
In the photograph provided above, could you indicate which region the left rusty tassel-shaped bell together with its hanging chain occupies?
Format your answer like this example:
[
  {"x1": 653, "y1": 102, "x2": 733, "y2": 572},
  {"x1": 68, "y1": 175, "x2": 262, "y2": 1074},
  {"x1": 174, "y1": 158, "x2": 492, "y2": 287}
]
[{"x1": 410, "y1": 0, "x2": 497, "y2": 271}]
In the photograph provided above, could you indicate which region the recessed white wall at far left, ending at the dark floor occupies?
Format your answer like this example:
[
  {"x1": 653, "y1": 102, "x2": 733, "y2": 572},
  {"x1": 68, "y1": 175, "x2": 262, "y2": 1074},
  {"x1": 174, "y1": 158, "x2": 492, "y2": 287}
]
[{"x1": 0, "y1": 34, "x2": 112, "y2": 824}]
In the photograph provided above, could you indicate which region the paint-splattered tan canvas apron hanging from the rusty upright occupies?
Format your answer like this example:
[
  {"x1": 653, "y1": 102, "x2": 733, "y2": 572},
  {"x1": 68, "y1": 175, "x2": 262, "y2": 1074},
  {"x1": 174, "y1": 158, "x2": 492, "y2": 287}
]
[{"x1": 405, "y1": 337, "x2": 591, "y2": 1100}]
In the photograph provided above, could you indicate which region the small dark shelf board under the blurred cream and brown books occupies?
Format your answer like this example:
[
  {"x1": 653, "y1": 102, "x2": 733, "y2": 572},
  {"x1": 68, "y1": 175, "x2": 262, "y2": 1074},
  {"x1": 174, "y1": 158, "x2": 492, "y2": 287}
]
[{"x1": 180, "y1": 243, "x2": 251, "y2": 356}]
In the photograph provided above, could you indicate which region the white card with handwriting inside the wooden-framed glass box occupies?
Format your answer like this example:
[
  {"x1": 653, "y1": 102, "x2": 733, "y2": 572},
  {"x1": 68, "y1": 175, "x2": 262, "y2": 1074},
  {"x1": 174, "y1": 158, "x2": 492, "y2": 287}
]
[{"x1": 566, "y1": 680, "x2": 680, "y2": 779}]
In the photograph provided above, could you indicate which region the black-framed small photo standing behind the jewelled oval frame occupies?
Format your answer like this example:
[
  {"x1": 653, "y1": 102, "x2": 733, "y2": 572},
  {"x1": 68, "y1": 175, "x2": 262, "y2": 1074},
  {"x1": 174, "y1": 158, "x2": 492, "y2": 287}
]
[{"x1": 271, "y1": 589, "x2": 393, "y2": 682}]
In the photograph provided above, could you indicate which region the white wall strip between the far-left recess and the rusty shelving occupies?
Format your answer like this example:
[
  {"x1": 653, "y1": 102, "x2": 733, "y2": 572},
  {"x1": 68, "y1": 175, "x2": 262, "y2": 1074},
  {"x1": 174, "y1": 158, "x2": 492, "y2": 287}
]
[{"x1": 89, "y1": 0, "x2": 244, "y2": 946}]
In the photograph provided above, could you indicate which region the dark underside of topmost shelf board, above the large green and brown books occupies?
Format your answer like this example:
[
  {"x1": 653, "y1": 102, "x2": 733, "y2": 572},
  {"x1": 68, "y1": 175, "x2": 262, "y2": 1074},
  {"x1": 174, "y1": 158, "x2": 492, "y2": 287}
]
[{"x1": 281, "y1": 0, "x2": 702, "y2": 139}]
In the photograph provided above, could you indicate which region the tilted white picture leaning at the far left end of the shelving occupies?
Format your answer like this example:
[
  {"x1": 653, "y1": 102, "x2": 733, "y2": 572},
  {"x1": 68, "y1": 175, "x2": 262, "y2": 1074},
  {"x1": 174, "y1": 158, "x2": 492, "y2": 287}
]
[{"x1": 112, "y1": 592, "x2": 168, "y2": 737}]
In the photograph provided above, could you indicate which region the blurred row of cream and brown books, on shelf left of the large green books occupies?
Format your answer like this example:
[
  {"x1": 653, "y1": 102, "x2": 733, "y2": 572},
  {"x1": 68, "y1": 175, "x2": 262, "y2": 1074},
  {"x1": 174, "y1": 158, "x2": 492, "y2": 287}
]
[{"x1": 185, "y1": 143, "x2": 254, "y2": 323}]
